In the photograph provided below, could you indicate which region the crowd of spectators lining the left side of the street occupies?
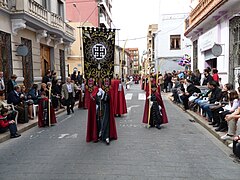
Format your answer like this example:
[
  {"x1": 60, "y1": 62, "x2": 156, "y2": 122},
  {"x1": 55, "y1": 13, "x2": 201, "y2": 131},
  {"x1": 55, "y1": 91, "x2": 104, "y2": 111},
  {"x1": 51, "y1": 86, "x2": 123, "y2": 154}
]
[{"x1": 0, "y1": 70, "x2": 84, "y2": 138}]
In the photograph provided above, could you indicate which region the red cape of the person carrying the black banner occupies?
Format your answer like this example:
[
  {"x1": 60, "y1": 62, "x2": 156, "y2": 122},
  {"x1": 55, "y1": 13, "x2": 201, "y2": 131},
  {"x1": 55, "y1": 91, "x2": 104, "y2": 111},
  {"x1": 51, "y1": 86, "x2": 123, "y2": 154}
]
[{"x1": 86, "y1": 87, "x2": 117, "y2": 142}]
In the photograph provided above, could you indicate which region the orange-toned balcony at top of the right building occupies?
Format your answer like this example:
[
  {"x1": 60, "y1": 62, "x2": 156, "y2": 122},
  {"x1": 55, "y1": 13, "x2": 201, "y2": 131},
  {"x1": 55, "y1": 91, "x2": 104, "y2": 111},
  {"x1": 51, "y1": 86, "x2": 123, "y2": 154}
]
[{"x1": 185, "y1": 0, "x2": 228, "y2": 35}]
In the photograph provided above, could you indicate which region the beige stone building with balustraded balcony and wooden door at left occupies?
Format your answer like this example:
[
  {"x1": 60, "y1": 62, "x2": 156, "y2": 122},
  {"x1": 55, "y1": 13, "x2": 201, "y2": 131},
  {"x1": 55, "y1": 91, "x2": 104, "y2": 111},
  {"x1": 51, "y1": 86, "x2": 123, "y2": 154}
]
[{"x1": 0, "y1": 0, "x2": 75, "y2": 89}]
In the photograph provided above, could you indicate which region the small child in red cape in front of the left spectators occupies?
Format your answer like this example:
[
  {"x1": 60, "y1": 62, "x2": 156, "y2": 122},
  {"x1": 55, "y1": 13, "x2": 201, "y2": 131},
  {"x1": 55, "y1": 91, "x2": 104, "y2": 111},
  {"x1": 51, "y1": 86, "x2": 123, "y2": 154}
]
[{"x1": 38, "y1": 91, "x2": 57, "y2": 127}]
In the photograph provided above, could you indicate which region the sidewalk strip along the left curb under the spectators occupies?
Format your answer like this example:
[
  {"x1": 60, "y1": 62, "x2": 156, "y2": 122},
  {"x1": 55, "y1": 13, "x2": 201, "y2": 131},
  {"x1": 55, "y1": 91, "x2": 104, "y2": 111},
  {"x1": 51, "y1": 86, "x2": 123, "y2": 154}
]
[{"x1": 0, "y1": 101, "x2": 78, "y2": 143}]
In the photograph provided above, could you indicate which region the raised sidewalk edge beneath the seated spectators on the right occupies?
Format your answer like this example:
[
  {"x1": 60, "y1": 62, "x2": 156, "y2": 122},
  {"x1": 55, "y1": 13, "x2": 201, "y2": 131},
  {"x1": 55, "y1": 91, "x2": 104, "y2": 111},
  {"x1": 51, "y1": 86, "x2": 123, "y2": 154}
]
[{"x1": 167, "y1": 94, "x2": 232, "y2": 146}]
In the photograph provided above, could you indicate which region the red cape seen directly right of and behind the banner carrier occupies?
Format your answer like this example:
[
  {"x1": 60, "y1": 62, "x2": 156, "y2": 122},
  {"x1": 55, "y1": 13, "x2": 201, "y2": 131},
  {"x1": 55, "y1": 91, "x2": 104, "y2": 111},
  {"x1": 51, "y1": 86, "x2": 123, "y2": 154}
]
[{"x1": 111, "y1": 79, "x2": 127, "y2": 115}]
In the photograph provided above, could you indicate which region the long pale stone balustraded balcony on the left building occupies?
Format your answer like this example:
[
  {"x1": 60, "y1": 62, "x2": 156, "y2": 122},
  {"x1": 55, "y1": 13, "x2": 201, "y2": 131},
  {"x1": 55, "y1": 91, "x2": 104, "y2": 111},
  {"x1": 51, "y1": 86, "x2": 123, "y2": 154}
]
[{"x1": 0, "y1": 0, "x2": 75, "y2": 42}]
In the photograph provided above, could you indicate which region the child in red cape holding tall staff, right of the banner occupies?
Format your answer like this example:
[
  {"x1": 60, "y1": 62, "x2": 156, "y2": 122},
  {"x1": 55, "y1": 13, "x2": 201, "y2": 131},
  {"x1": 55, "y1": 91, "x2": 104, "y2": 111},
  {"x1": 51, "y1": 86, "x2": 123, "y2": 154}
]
[{"x1": 142, "y1": 76, "x2": 168, "y2": 129}]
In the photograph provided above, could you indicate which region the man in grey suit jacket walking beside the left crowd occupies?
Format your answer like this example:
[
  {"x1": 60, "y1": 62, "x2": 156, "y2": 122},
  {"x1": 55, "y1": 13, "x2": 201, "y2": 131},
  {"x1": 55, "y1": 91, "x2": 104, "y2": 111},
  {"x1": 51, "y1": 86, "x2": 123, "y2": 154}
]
[{"x1": 62, "y1": 77, "x2": 78, "y2": 115}]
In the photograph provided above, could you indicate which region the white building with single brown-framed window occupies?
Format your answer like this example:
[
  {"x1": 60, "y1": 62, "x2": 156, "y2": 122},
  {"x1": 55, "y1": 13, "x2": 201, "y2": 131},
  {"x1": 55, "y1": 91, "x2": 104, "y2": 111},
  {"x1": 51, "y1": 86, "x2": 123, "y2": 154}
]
[{"x1": 154, "y1": 13, "x2": 191, "y2": 73}]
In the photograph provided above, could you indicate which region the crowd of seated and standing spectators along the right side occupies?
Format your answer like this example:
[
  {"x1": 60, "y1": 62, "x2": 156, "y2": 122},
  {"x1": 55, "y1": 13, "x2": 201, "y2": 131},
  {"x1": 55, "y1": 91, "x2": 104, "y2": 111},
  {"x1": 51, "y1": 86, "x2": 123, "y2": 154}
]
[{"x1": 167, "y1": 68, "x2": 240, "y2": 161}]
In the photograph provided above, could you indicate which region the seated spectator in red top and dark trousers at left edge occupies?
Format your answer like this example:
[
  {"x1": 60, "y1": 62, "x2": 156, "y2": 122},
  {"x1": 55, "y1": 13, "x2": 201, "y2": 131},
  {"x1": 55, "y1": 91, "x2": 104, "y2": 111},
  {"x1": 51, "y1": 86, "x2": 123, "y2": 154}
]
[{"x1": 0, "y1": 107, "x2": 21, "y2": 138}]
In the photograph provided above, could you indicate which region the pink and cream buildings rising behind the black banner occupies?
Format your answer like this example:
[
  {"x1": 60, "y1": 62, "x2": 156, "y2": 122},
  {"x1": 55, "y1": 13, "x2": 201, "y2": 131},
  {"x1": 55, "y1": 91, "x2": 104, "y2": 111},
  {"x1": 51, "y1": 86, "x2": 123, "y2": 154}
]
[{"x1": 66, "y1": 0, "x2": 112, "y2": 73}]
